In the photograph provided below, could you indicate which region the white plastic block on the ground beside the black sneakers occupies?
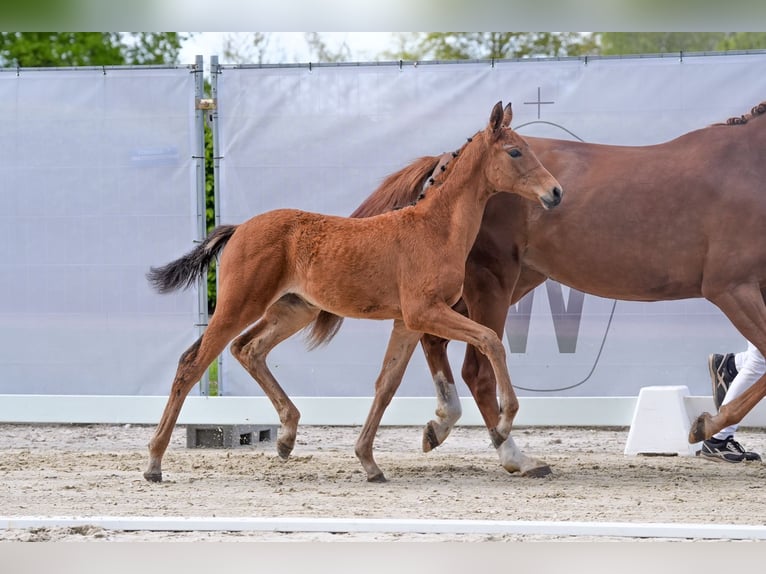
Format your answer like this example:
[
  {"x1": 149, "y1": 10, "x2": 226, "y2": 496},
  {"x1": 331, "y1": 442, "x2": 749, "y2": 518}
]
[{"x1": 625, "y1": 385, "x2": 699, "y2": 456}]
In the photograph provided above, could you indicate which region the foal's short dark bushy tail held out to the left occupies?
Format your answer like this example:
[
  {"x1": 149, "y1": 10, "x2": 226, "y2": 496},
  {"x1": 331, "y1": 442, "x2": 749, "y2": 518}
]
[{"x1": 146, "y1": 225, "x2": 237, "y2": 293}]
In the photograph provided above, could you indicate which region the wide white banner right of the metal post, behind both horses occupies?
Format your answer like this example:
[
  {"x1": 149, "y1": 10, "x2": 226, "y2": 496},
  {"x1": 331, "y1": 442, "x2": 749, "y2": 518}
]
[{"x1": 217, "y1": 54, "x2": 766, "y2": 396}]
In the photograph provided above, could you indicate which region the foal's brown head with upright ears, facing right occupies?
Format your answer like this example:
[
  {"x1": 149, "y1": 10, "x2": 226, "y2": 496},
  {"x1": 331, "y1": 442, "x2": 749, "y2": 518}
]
[{"x1": 482, "y1": 102, "x2": 564, "y2": 209}]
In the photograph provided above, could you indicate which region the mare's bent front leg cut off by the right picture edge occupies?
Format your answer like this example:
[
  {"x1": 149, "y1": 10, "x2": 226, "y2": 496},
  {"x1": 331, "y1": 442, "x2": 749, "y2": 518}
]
[{"x1": 689, "y1": 284, "x2": 766, "y2": 443}]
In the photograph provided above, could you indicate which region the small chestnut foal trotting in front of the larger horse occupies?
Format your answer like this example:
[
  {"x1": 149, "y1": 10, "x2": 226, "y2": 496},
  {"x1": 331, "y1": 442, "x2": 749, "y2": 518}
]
[{"x1": 144, "y1": 102, "x2": 562, "y2": 482}]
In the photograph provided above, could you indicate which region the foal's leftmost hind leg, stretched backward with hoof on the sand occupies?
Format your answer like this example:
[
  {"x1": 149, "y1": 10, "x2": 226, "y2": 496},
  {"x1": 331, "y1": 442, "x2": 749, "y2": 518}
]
[{"x1": 144, "y1": 313, "x2": 258, "y2": 482}]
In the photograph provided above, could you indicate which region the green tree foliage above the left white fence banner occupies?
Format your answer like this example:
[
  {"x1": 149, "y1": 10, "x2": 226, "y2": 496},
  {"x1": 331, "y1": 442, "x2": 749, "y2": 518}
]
[{"x1": 0, "y1": 32, "x2": 186, "y2": 67}]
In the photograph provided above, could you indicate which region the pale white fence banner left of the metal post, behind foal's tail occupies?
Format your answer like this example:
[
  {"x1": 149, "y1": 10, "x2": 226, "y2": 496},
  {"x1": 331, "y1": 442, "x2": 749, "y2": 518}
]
[{"x1": 0, "y1": 68, "x2": 198, "y2": 395}]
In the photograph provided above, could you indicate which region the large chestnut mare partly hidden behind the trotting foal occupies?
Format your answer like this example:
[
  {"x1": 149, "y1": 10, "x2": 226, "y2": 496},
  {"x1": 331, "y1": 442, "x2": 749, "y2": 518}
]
[{"x1": 313, "y1": 102, "x2": 766, "y2": 468}]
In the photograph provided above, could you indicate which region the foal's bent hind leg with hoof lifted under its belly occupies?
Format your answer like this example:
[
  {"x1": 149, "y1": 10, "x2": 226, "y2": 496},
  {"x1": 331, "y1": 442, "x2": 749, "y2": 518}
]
[{"x1": 231, "y1": 295, "x2": 319, "y2": 459}]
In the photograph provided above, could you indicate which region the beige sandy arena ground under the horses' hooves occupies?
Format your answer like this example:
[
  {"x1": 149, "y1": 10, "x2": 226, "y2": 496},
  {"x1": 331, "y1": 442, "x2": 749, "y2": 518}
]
[{"x1": 0, "y1": 425, "x2": 766, "y2": 541}]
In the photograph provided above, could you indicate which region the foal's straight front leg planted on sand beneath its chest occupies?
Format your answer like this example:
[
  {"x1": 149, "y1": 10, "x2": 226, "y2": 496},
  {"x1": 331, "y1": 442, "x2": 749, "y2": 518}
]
[{"x1": 355, "y1": 319, "x2": 422, "y2": 482}]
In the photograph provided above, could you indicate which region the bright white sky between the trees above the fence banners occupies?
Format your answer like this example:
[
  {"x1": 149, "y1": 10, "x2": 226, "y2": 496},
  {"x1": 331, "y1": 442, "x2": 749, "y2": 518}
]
[{"x1": 179, "y1": 32, "x2": 394, "y2": 64}]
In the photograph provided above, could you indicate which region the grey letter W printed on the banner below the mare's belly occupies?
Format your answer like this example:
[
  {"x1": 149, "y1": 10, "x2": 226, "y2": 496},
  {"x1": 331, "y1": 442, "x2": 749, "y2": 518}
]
[{"x1": 505, "y1": 279, "x2": 585, "y2": 353}]
